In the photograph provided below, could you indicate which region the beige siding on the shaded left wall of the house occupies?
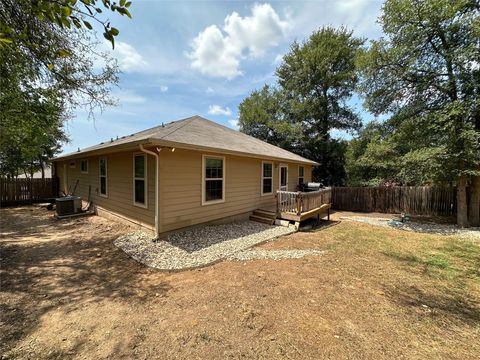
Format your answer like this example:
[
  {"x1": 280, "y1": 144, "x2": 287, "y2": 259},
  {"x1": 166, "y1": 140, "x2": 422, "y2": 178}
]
[{"x1": 57, "y1": 151, "x2": 155, "y2": 228}]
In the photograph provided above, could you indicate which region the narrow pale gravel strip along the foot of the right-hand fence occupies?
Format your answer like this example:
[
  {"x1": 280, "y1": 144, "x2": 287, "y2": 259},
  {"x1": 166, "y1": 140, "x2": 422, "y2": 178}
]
[{"x1": 341, "y1": 216, "x2": 480, "y2": 240}]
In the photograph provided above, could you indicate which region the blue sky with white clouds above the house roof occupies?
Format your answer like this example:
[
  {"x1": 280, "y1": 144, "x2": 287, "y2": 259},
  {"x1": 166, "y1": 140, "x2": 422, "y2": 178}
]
[{"x1": 64, "y1": 0, "x2": 381, "y2": 152}]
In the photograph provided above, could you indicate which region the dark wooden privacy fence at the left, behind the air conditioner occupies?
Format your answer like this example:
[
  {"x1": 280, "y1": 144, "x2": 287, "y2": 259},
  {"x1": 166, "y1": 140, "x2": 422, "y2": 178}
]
[{"x1": 0, "y1": 178, "x2": 58, "y2": 206}]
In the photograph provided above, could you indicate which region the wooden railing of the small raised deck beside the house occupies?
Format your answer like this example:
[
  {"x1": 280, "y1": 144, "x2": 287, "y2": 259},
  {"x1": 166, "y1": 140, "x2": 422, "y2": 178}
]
[{"x1": 277, "y1": 188, "x2": 332, "y2": 215}]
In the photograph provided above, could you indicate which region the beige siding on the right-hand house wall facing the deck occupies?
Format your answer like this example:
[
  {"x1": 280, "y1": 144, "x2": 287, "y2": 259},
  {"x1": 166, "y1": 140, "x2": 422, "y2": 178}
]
[{"x1": 160, "y1": 149, "x2": 311, "y2": 232}]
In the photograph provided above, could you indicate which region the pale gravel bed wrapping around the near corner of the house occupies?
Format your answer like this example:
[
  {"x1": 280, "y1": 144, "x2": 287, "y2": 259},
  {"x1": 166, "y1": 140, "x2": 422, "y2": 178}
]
[{"x1": 113, "y1": 221, "x2": 295, "y2": 270}]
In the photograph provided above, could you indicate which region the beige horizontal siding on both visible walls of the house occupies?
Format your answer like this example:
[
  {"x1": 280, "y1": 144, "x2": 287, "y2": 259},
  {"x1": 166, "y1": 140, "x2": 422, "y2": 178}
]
[{"x1": 57, "y1": 149, "x2": 312, "y2": 232}]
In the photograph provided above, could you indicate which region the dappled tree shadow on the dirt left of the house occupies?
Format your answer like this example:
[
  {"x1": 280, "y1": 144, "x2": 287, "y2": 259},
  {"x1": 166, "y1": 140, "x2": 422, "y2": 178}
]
[{"x1": 0, "y1": 208, "x2": 171, "y2": 353}]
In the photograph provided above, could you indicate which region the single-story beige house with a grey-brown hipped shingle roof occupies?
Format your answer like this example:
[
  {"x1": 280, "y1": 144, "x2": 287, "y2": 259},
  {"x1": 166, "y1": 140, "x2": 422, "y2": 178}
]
[{"x1": 53, "y1": 116, "x2": 318, "y2": 234}]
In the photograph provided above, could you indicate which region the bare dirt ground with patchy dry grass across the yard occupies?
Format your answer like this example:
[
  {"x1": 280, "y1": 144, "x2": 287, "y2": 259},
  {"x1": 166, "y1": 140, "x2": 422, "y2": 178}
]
[{"x1": 0, "y1": 207, "x2": 480, "y2": 359}]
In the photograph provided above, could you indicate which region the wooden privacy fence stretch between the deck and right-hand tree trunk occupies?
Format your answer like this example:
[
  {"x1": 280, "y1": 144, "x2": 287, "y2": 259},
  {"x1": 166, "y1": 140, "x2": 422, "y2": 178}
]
[{"x1": 332, "y1": 186, "x2": 457, "y2": 216}]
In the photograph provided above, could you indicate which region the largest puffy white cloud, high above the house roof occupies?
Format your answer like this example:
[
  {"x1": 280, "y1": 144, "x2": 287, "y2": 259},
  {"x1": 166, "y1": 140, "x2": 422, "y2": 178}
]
[{"x1": 187, "y1": 4, "x2": 291, "y2": 79}]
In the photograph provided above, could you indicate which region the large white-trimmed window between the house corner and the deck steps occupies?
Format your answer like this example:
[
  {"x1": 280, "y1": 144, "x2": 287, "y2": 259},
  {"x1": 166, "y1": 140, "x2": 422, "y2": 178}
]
[{"x1": 202, "y1": 156, "x2": 225, "y2": 205}]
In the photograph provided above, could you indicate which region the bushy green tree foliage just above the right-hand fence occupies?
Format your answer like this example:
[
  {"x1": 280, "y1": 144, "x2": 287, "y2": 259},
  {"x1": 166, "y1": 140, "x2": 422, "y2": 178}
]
[{"x1": 346, "y1": 118, "x2": 450, "y2": 186}]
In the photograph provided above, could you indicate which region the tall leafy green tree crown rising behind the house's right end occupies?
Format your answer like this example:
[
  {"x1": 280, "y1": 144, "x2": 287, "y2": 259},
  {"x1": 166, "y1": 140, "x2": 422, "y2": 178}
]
[{"x1": 276, "y1": 27, "x2": 363, "y2": 137}]
